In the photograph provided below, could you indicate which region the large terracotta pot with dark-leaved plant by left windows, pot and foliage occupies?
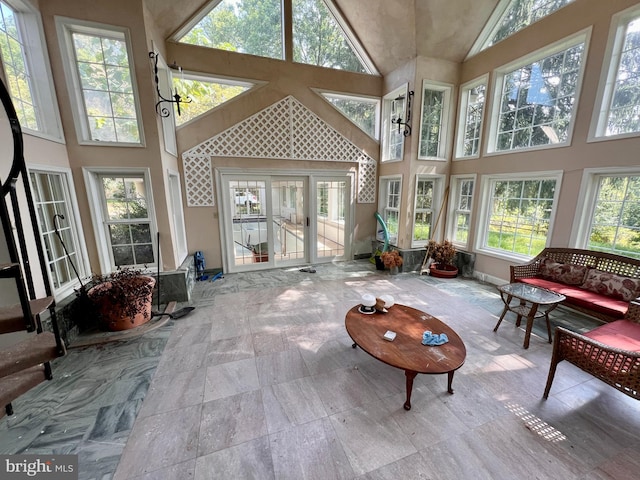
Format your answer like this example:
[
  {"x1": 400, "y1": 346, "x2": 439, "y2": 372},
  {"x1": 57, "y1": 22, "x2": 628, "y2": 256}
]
[{"x1": 87, "y1": 268, "x2": 156, "y2": 331}]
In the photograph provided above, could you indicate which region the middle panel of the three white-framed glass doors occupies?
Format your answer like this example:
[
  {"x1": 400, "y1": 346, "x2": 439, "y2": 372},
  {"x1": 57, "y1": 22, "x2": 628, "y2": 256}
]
[{"x1": 271, "y1": 177, "x2": 309, "y2": 266}]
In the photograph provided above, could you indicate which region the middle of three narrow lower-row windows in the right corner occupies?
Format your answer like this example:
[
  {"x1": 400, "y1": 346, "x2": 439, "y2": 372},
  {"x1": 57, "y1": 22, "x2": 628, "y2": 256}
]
[{"x1": 411, "y1": 175, "x2": 442, "y2": 247}]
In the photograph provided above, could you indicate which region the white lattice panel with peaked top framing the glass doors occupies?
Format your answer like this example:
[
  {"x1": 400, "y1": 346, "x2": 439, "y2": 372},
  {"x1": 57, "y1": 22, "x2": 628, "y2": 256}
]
[{"x1": 182, "y1": 96, "x2": 376, "y2": 206}]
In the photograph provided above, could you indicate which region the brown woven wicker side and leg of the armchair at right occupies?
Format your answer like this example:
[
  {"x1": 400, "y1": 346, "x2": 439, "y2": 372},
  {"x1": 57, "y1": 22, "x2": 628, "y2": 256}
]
[{"x1": 544, "y1": 324, "x2": 640, "y2": 400}]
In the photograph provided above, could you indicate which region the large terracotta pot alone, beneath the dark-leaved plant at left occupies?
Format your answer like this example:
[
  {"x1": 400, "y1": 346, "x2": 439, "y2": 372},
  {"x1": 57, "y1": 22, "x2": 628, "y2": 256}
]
[{"x1": 87, "y1": 276, "x2": 156, "y2": 332}]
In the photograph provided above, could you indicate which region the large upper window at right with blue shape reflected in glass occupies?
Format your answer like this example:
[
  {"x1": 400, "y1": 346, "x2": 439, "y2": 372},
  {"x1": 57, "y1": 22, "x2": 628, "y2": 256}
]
[{"x1": 489, "y1": 34, "x2": 586, "y2": 152}]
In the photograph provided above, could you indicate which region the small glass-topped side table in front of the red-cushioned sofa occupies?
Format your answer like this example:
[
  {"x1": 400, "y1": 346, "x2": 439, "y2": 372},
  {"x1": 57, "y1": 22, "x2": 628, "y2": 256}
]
[{"x1": 493, "y1": 282, "x2": 566, "y2": 348}]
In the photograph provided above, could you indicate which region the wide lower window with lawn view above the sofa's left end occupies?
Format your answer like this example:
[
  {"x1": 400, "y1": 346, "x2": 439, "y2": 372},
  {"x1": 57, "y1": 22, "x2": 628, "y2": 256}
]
[{"x1": 479, "y1": 174, "x2": 560, "y2": 258}]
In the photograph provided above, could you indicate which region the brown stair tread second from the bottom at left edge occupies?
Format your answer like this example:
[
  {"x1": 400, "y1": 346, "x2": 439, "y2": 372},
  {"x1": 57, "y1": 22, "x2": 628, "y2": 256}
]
[{"x1": 0, "y1": 332, "x2": 65, "y2": 378}]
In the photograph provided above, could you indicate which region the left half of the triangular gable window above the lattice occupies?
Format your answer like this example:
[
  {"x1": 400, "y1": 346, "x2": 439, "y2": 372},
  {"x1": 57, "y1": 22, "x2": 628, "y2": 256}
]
[{"x1": 178, "y1": 0, "x2": 284, "y2": 59}]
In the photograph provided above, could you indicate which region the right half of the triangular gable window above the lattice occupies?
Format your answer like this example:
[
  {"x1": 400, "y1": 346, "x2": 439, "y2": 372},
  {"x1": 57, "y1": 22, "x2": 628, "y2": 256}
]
[{"x1": 293, "y1": 0, "x2": 375, "y2": 73}]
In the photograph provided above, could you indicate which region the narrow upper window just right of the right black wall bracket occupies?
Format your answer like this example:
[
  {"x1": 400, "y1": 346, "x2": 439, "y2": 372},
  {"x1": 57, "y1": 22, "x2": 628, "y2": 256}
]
[{"x1": 418, "y1": 81, "x2": 453, "y2": 160}]
